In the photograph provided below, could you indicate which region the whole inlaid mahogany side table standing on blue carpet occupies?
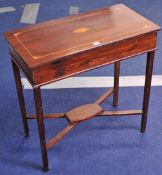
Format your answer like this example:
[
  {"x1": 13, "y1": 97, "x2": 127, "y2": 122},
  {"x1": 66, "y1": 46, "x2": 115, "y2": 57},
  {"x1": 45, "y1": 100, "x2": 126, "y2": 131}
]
[{"x1": 4, "y1": 4, "x2": 160, "y2": 171}]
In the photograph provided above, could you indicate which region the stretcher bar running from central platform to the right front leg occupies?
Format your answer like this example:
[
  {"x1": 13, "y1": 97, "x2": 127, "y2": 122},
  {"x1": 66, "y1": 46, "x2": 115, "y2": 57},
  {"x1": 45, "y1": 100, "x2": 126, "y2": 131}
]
[{"x1": 99, "y1": 110, "x2": 143, "y2": 116}]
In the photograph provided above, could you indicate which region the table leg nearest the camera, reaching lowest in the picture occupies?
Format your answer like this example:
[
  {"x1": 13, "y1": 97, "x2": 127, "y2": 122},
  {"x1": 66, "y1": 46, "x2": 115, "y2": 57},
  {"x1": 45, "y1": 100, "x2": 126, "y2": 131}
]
[{"x1": 33, "y1": 87, "x2": 48, "y2": 171}]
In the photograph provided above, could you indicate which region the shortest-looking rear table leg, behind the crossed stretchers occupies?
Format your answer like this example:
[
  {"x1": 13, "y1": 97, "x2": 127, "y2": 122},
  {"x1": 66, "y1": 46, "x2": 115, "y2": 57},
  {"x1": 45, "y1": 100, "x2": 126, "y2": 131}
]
[{"x1": 113, "y1": 62, "x2": 120, "y2": 106}]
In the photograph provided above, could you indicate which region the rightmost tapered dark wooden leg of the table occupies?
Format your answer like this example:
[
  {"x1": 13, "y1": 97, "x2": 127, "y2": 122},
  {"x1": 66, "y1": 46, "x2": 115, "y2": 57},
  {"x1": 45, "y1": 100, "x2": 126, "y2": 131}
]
[{"x1": 141, "y1": 51, "x2": 155, "y2": 132}]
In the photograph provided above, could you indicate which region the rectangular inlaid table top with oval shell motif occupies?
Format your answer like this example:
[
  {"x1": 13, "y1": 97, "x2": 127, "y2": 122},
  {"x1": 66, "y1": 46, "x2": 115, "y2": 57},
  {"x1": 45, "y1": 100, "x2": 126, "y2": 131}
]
[{"x1": 4, "y1": 4, "x2": 160, "y2": 68}]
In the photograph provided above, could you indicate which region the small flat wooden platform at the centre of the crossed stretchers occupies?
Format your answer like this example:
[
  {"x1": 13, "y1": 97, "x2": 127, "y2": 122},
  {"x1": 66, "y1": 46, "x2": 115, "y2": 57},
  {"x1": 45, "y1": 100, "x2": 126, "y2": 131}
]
[{"x1": 65, "y1": 103, "x2": 103, "y2": 124}]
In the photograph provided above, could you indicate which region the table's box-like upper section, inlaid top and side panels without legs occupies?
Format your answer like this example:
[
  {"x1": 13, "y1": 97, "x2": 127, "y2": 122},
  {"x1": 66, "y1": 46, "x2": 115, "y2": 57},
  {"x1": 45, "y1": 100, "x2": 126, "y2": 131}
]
[{"x1": 4, "y1": 4, "x2": 160, "y2": 86}]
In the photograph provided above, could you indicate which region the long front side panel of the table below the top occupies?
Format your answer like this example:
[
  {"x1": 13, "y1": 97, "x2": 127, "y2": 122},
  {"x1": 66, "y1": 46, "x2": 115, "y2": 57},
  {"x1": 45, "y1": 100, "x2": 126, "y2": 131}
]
[{"x1": 33, "y1": 33, "x2": 156, "y2": 85}]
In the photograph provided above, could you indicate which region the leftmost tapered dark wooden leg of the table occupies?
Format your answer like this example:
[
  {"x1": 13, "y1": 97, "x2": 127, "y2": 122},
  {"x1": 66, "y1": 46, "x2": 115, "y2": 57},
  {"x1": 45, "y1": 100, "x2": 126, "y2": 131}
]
[{"x1": 12, "y1": 60, "x2": 29, "y2": 136}]
